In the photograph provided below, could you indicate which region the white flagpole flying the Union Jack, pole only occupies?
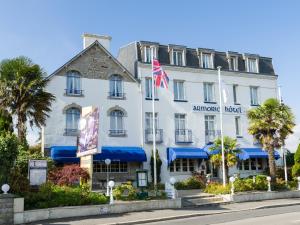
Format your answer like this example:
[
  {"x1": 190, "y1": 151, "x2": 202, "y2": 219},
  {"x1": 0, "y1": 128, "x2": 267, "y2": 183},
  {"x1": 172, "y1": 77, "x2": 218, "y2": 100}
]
[{"x1": 151, "y1": 48, "x2": 157, "y2": 187}]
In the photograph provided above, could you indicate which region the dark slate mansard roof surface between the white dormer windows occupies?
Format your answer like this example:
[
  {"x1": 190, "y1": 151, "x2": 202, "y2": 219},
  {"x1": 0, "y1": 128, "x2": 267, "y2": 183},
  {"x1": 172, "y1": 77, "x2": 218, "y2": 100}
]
[{"x1": 137, "y1": 41, "x2": 275, "y2": 75}]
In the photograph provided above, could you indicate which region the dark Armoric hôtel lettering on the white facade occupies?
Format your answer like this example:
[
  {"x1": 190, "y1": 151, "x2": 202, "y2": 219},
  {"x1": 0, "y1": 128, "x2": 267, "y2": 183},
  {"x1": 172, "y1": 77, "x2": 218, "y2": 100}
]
[{"x1": 192, "y1": 104, "x2": 245, "y2": 114}]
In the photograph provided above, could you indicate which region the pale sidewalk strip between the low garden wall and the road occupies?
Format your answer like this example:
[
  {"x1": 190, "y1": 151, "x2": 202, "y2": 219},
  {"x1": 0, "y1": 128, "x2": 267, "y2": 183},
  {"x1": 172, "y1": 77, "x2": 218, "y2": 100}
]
[{"x1": 32, "y1": 198, "x2": 300, "y2": 225}]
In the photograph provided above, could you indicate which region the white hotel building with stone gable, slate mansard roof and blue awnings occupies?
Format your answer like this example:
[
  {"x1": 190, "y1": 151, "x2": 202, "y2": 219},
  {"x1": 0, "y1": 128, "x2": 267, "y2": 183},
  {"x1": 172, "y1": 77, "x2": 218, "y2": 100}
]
[{"x1": 43, "y1": 35, "x2": 278, "y2": 187}]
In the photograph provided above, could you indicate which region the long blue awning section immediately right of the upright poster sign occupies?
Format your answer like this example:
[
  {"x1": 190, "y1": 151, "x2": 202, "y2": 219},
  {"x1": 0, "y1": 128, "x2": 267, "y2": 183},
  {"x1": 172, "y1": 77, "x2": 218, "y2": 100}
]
[{"x1": 94, "y1": 146, "x2": 147, "y2": 162}]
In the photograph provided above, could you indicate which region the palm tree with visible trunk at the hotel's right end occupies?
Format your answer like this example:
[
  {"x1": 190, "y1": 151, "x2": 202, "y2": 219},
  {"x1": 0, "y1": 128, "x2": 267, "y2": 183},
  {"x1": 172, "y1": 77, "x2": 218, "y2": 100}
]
[{"x1": 247, "y1": 98, "x2": 295, "y2": 182}]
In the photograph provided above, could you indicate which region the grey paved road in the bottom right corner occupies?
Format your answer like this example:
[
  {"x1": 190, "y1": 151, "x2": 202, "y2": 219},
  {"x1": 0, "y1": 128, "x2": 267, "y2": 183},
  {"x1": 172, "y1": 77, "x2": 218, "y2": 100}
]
[{"x1": 147, "y1": 205, "x2": 300, "y2": 225}]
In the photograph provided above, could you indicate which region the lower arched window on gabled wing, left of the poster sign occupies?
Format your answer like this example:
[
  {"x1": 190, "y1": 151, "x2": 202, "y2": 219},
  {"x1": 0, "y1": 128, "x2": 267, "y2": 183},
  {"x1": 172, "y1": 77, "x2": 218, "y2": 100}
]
[{"x1": 65, "y1": 107, "x2": 80, "y2": 136}]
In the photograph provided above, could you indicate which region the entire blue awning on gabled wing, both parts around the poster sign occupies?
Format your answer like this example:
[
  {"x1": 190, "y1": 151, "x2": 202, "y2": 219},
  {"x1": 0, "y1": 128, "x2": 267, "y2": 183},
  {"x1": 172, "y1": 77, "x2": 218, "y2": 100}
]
[{"x1": 51, "y1": 146, "x2": 147, "y2": 163}]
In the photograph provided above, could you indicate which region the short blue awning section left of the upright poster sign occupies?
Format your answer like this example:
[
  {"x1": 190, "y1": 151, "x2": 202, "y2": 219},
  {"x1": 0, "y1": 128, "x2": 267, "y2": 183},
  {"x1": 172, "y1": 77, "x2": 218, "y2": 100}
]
[{"x1": 50, "y1": 146, "x2": 80, "y2": 163}]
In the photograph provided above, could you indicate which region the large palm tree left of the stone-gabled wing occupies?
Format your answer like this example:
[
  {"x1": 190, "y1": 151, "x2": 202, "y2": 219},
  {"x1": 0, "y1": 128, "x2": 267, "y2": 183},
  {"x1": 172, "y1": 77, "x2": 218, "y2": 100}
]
[{"x1": 0, "y1": 57, "x2": 55, "y2": 141}]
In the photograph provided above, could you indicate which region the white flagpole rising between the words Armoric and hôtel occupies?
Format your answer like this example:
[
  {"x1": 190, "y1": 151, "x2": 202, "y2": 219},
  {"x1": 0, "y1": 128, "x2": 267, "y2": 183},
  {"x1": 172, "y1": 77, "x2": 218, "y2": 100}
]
[{"x1": 217, "y1": 66, "x2": 226, "y2": 186}]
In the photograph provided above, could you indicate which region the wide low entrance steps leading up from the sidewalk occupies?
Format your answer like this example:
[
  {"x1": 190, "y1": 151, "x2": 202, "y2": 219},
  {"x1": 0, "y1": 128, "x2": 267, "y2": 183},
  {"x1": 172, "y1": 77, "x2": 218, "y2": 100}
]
[{"x1": 181, "y1": 193, "x2": 227, "y2": 208}]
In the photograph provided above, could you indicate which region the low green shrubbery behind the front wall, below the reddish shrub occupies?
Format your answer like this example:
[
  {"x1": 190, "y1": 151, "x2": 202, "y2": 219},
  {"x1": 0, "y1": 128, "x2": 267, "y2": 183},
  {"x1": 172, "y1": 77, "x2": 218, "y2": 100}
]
[{"x1": 25, "y1": 183, "x2": 108, "y2": 210}]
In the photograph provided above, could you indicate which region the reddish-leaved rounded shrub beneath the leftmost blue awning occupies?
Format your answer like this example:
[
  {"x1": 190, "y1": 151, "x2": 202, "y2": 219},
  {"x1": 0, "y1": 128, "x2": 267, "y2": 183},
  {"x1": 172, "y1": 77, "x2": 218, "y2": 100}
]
[{"x1": 48, "y1": 164, "x2": 90, "y2": 186}]
